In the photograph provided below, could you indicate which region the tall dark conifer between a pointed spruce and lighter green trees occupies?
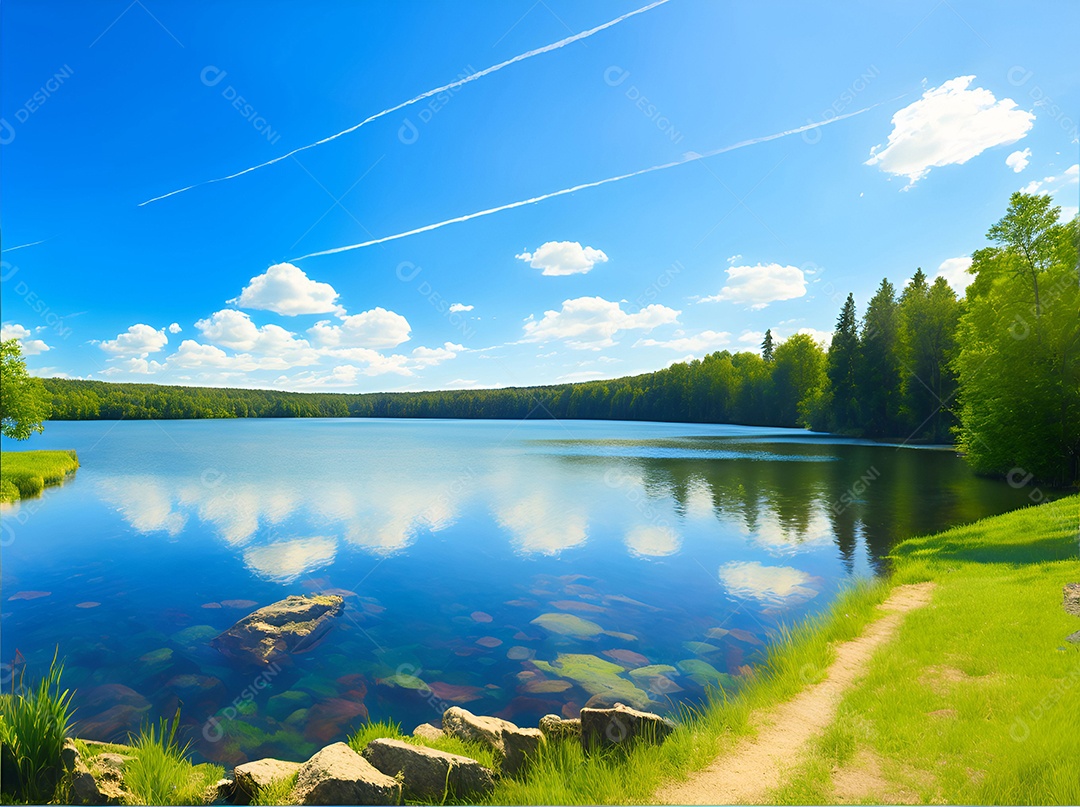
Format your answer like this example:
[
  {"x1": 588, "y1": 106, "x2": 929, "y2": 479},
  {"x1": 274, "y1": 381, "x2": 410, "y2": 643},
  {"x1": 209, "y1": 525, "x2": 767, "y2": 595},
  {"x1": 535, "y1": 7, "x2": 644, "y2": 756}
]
[{"x1": 858, "y1": 280, "x2": 900, "y2": 436}]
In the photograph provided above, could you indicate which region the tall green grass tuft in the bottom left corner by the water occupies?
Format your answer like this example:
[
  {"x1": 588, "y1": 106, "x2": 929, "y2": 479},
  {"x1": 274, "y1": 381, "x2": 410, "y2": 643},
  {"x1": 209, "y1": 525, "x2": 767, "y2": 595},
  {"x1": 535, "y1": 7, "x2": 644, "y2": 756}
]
[{"x1": 0, "y1": 654, "x2": 72, "y2": 804}]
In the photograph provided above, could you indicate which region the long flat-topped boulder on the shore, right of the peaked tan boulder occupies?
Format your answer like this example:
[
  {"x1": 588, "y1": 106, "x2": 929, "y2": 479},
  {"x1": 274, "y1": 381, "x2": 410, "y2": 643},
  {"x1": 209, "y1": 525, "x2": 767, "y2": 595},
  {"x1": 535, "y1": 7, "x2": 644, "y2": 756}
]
[{"x1": 364, "y1": 739, "x2": 495, "y2": 804}]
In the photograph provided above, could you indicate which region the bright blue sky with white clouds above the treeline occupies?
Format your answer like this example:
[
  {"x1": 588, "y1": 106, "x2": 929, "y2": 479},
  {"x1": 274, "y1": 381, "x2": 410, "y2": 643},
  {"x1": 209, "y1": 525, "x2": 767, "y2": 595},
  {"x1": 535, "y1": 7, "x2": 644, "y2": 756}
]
[{"x1": 0, "y1": 0, "x2": 1080, "y2": 391}]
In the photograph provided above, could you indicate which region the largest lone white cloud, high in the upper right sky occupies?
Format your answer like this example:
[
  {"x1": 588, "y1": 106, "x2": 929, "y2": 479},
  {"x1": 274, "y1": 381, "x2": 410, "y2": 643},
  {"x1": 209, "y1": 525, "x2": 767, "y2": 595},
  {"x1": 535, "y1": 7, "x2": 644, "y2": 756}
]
[{"x1": 866, "y1": 76, "x2": 1035, "y2": 188}]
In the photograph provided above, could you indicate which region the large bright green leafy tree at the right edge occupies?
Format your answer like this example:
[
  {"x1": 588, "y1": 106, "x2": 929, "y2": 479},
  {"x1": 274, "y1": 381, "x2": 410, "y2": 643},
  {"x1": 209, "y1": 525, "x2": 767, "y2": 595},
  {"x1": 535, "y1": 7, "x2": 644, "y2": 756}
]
[{"x1": 954, "y1": 193, "x2": 1080, "y2": 484}]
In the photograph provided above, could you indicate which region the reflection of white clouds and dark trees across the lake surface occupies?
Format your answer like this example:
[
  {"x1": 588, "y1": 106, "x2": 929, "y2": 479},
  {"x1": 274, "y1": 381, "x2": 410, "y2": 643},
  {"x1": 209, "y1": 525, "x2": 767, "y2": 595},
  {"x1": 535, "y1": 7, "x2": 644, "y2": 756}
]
[{"x1": 90, "y1": 434, "x2": 1054, "y2": 582}]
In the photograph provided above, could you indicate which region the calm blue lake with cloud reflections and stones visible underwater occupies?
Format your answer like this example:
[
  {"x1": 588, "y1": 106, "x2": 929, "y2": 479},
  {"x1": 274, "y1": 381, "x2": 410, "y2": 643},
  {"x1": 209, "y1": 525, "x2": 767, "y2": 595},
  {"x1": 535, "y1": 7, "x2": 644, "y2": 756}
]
[{"x1": 0, "y1": 419, "x2": 1054, "y2": 764}]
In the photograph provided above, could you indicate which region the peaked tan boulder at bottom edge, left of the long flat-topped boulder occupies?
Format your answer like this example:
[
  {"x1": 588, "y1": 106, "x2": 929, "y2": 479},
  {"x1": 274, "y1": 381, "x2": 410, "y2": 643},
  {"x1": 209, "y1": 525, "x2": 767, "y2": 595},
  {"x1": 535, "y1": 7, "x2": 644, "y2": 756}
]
[{"x1": 293, "y1": 742, "x2": 402, "y2": 805}]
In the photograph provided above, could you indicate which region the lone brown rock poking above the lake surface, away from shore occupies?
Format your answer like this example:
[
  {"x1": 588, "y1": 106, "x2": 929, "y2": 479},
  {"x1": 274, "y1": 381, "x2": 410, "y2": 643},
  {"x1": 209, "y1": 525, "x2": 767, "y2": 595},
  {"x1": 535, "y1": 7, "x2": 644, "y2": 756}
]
[{"x1": 211, "y1": 594, "x2": 345, "y2": 665}]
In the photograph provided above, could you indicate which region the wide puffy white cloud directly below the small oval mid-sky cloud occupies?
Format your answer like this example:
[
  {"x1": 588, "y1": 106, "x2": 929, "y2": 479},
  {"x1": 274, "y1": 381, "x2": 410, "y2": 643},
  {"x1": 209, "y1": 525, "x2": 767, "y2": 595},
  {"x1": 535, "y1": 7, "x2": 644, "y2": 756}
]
[{"x1": 522, "y1": 297, "x2": 679, "y2": 350}]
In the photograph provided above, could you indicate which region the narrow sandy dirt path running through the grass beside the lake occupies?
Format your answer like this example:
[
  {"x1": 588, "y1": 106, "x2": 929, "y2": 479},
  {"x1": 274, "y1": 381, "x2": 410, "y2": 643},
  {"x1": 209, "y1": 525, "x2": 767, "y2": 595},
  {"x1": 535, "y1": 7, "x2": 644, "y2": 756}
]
[{"x1": 657, "y1": 583, "x2": 933, "y2": 805}]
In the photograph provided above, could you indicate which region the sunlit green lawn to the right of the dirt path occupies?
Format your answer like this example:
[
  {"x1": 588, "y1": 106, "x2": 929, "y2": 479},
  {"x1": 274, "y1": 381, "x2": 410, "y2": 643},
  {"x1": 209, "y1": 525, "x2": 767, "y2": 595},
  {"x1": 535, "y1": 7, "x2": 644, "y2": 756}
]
[{"x1": 770, "y1": 496, "x2": 1080, "y2": 805}]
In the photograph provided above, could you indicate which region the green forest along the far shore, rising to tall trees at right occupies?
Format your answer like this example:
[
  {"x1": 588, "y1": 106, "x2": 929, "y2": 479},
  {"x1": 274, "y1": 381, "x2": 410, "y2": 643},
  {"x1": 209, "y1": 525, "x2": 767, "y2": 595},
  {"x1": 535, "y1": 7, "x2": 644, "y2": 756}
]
[{"x1": 33, "y1": 192, "x2": 1080, "y2": 484}]
